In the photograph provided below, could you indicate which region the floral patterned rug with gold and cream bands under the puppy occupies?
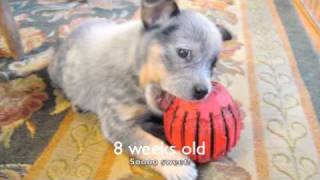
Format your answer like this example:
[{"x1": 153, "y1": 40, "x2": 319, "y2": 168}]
[{"x1": 0, "y1": 0, "x2": 320, "y2": 180}]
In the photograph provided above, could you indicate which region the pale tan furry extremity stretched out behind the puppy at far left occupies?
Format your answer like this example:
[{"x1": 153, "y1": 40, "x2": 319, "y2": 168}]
[{"x1": 0, "y1": 47, "x2": 55, "y2": 80}]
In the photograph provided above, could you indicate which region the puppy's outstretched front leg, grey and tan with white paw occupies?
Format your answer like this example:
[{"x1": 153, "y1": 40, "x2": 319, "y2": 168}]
[{"x1": 98, "y1": 104, "x2": 197, "y2": 180}]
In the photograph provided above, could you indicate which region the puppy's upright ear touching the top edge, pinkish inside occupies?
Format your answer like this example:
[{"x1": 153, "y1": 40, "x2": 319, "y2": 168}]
[{"x1": 141, "y1": 0, "x2": 180, "y2": 29}]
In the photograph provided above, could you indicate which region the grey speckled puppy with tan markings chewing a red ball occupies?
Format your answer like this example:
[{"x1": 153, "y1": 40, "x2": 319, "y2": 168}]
[{"x1": 9, "y1": 0, "x2": 231, "y2": 180}]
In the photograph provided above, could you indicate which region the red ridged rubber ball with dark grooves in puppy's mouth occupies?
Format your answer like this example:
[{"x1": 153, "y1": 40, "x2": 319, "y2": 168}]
[{"x1": 164, "y1": 82, "x2": 243, "y2": 163}]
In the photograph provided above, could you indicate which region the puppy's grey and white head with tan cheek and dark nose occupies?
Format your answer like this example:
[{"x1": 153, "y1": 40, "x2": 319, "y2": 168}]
[{"x1": 140, "y1": 0, "x2": 231, "y2": 100}]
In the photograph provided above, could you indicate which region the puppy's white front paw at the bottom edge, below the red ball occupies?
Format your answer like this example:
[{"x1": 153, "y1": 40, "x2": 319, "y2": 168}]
[{"x1": 159, "y1": 161, "x2": 198, "y2": 180}]
